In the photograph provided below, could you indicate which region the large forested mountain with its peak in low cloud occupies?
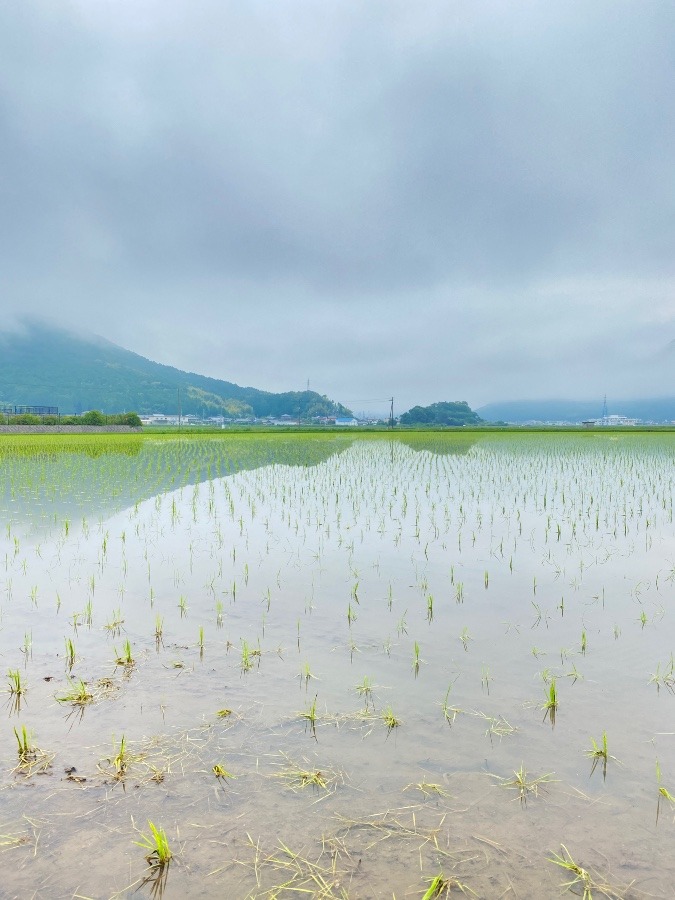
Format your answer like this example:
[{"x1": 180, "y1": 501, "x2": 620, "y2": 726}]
[{"x1": 0, "y1": 321, "x2": 349, "y2": 417}]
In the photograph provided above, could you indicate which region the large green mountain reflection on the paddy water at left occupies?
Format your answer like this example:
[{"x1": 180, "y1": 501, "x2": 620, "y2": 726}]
[{"x1": 0, "y1": 434, "x2": 351, "y2": 528}]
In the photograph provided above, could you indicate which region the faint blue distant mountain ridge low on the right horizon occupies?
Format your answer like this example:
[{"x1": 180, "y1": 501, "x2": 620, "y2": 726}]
[{"x1": 477, "y1": 397, "x2": 675, "y2": 424}]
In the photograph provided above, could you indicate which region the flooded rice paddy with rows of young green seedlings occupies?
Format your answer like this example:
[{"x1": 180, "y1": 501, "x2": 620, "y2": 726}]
[{"x1": 0, "y1": 433, "x2": 675, "y2": 898}]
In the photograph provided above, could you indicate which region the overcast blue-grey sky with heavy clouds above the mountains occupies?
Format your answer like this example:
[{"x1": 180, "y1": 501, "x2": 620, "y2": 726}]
[{"x1": 0, "y1": 0, "x2": 675, "y2": 412}]
